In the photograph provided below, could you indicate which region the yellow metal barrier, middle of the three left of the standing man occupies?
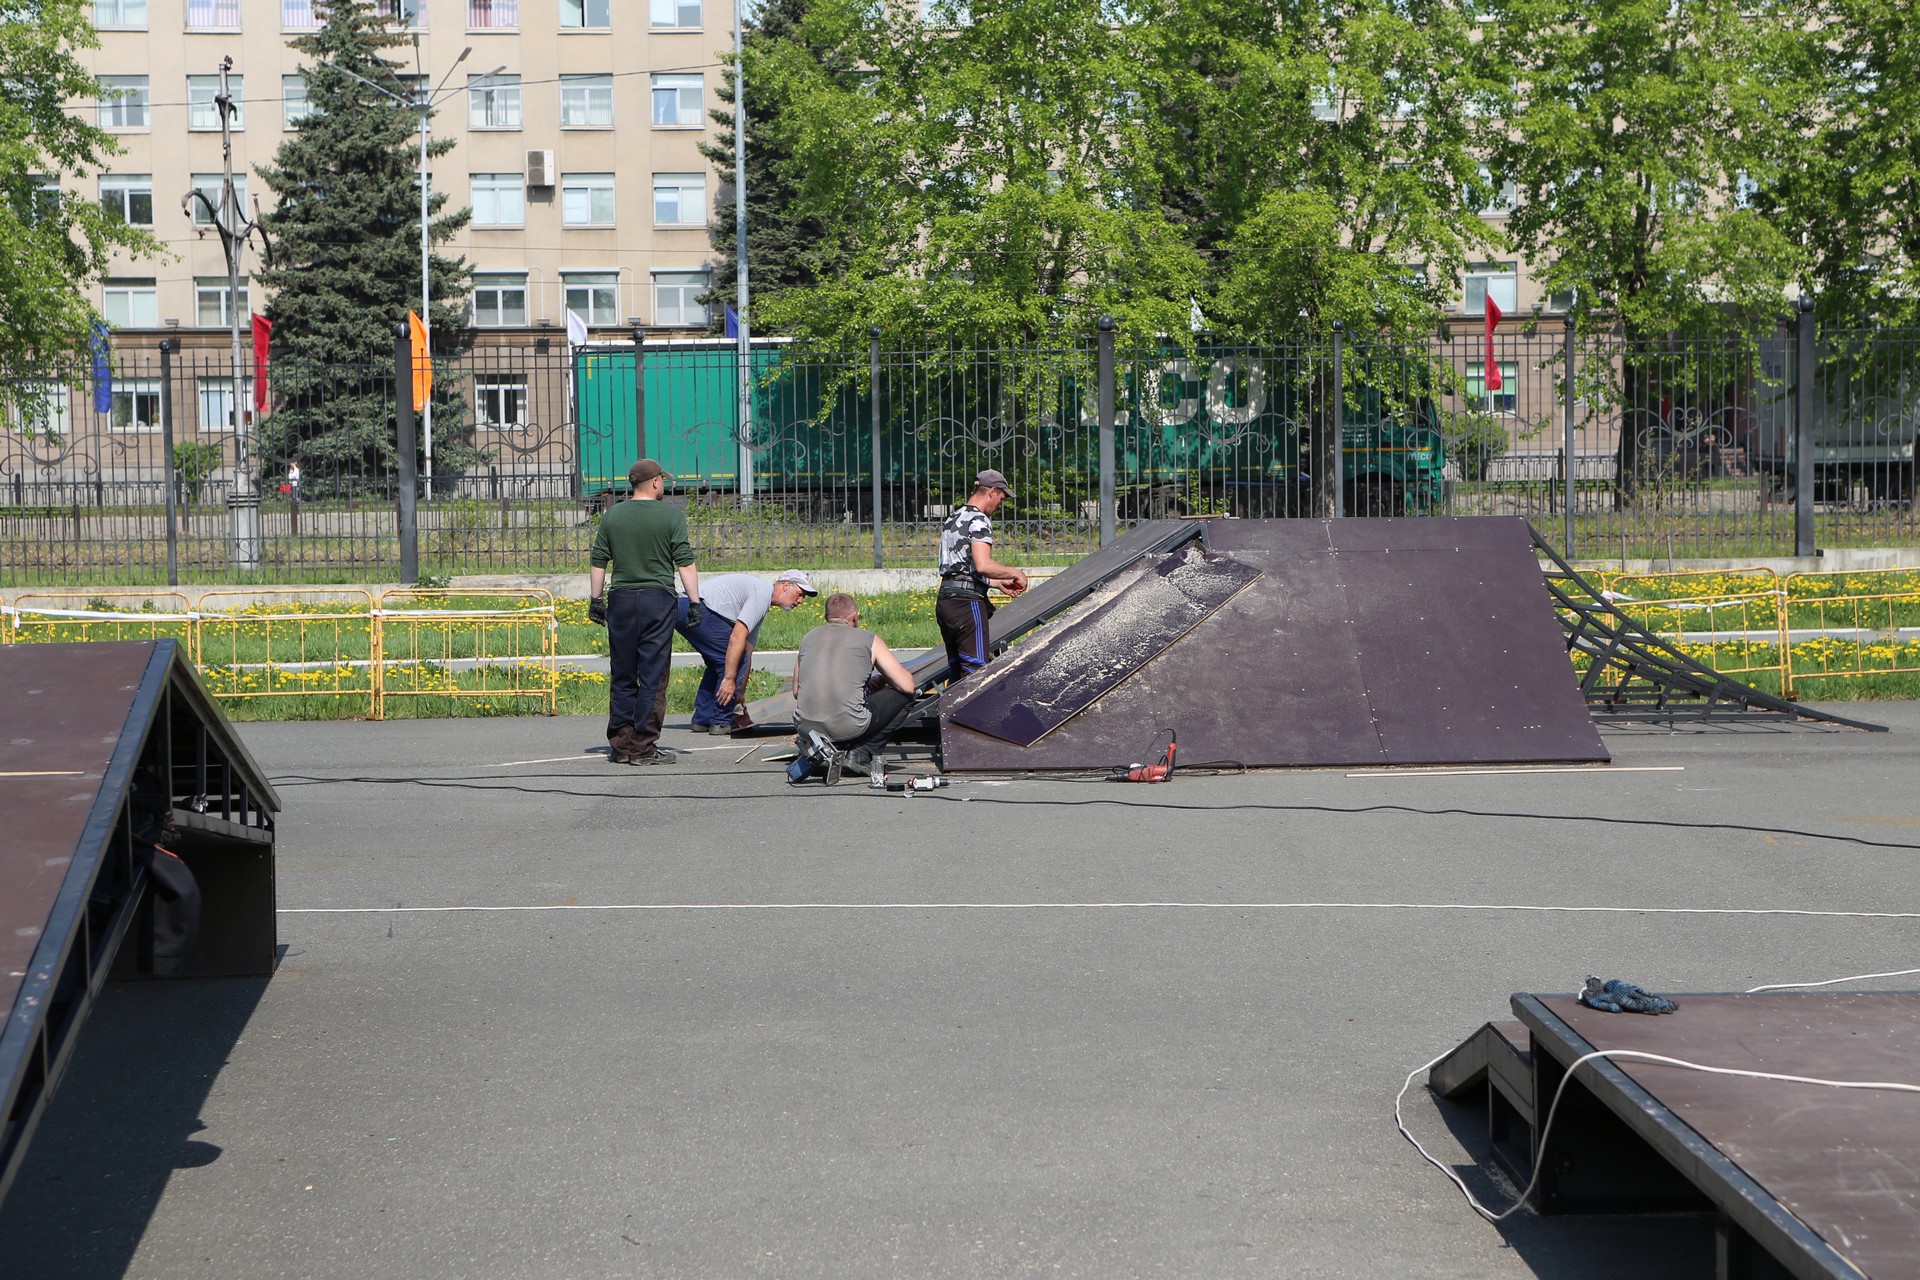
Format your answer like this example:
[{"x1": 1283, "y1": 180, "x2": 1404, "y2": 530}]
[{"x1": 196, "y1": 587, "x2": 380, "y2": 720}]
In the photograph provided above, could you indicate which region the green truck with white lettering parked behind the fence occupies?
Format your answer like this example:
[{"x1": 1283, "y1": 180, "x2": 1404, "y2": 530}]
[{"x1": 574, "y1": 340, "x2": 1446, "y2": 520}]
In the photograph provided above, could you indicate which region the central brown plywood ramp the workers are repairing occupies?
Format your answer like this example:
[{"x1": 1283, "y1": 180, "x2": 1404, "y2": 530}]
[{"x1": 941, "y1": 518, "x2": 1609, "y2": 771}]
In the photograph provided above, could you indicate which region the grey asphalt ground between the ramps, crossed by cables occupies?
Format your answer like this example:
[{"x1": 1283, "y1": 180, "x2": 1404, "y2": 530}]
[{"x1": 0, "y1": 704, "x2": 1920, "y2": 1280}]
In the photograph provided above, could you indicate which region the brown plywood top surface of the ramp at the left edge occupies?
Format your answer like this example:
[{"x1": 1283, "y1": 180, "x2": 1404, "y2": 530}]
[{"x1": 0, "y1": 643, "x2": 154, "y2": 1009}]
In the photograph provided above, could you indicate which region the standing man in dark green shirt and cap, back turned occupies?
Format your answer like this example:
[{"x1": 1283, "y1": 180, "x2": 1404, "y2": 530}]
[{"x1": 588, "y1": 459, "x2": 701, "y2": 764}]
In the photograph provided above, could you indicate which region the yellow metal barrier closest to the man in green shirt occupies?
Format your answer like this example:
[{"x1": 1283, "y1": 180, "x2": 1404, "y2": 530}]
[{"x1": 374, "y1": 587, "x2": 559, "y2": 720}]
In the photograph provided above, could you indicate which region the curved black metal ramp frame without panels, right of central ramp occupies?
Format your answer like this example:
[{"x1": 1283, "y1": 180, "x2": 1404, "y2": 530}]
[{"x1": 1526, "y1": 524, "x2": 1887, "y2": 733}]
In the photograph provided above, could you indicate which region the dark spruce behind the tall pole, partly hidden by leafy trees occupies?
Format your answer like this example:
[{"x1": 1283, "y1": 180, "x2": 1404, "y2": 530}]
[{"x1": 701, "y1": 0, "x2": 858, "y2": 332}]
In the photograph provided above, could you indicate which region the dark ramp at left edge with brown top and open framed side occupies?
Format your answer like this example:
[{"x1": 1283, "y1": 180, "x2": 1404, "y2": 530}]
[{"x1": 0, "y1": 641, "x2": 278, "y2": 1196}]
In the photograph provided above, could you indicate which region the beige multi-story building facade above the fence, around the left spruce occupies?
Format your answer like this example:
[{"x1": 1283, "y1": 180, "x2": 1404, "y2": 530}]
[{"x1": 61, "y1": 0, "x2": 733, "y2": 360}]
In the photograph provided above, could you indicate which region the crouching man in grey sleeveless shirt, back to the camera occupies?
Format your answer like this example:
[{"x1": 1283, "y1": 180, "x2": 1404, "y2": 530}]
[{"x1": 793, "y1": 591, "x2": 914, "y2": 787}]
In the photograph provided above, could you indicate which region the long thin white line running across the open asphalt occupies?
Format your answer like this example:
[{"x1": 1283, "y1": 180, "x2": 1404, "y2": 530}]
[{"x1": 278, "y1": 902, "x2": 1920, "y2": 919}]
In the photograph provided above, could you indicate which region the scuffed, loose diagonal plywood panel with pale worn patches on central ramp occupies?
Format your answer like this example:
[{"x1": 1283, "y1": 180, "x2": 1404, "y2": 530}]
[{"x1": 943, "y1": 547, "x2": 1260, "y2": 747}]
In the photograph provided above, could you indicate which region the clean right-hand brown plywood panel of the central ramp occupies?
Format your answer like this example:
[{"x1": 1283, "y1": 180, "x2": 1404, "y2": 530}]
[{"x1": 1334, "y1": 545, "x2": 1609, "y2": 764}]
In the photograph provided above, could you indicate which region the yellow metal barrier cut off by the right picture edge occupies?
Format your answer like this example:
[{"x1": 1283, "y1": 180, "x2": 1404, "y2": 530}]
[{"x1": 1782, "y1": 572, "x2": 1920, "y2": 702}]
